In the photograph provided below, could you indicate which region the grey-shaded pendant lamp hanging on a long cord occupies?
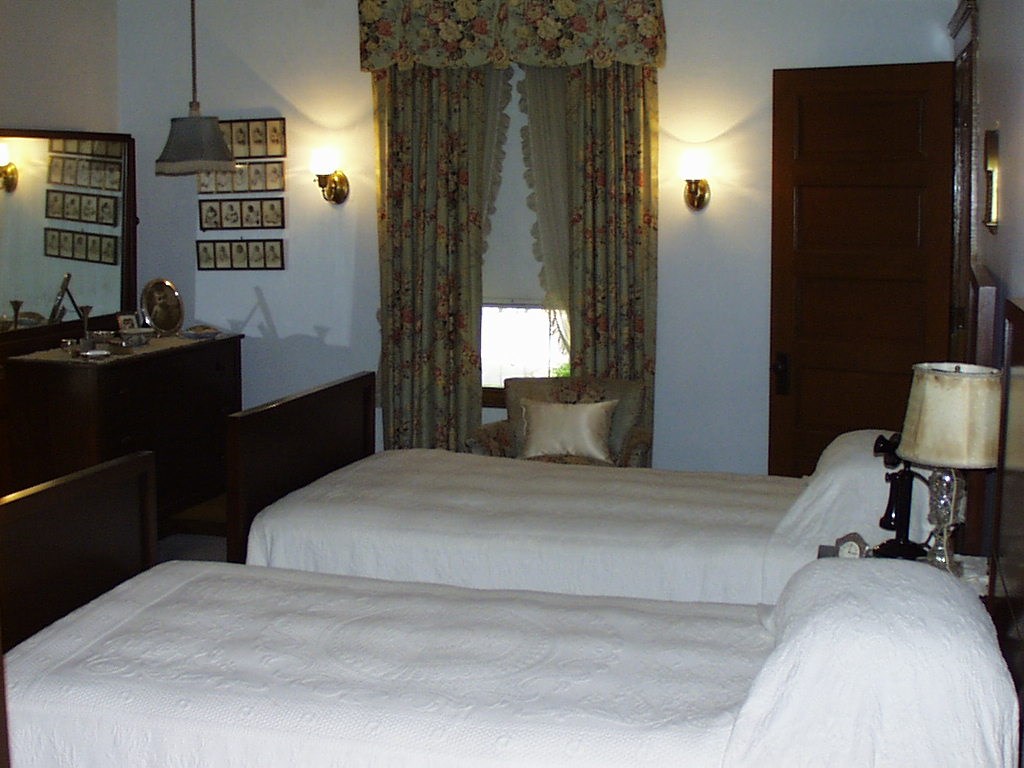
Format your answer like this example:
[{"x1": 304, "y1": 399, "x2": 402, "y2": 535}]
[{"x1": 157, "y1": 0, "x2": 234, "y2": 176}]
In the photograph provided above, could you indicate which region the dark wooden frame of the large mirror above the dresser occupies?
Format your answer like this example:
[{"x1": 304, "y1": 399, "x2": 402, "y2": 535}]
[{"x1": 0, "y1": 128, "x2": 138, "y2": 360}]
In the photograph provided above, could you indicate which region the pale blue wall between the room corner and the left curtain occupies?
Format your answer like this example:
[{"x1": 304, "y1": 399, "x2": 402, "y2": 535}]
[{"x1": 118, "y1": 0, "x2": 379, "y2": 406}]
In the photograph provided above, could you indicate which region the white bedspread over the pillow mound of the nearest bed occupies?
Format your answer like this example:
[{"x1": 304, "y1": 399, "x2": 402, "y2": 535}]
[{"x1": 723, "y1": 558, "x2": 1019, "y2": 768}]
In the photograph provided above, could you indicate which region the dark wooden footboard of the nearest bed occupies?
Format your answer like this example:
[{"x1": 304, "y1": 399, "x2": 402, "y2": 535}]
[{"x1": 0, "y1": 452, "x2": 157, "y2": 650}]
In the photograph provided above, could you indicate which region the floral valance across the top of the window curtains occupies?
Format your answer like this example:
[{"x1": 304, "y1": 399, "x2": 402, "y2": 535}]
[{"x1": 359, "y1": 0, "x2": 665, "y2": 71}]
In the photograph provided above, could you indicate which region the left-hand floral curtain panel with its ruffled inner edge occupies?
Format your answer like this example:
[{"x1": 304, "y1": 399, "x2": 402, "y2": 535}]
[{"x1": 374, "y1": 67, "x2": 511, "y2": 450}]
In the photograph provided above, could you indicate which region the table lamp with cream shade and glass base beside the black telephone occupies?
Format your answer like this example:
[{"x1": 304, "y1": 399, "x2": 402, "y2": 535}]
[{"x1": 896, "y1": 362, "x2": 1001, "y2": 575}]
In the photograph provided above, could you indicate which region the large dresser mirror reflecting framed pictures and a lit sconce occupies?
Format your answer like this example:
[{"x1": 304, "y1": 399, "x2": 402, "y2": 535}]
[{"x1": 0, "y1": 129, "x2": 136, "y2": 337}]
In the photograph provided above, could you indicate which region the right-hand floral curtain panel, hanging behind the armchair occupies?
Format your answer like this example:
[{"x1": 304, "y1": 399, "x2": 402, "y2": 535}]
[{"x1": 567, "y1": 63, "x2": 657, "y2": 450}]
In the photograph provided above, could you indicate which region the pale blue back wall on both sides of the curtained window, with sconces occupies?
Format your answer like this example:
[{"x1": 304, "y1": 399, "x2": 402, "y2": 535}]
[{"x1": 9, "y1": 0, "x2": 966, "y2": 472}]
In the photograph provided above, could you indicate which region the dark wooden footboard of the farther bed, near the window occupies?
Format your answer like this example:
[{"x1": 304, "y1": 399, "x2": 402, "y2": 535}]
[{"x1": 227, "y1": 373, "x2": 377, "y2": 562}]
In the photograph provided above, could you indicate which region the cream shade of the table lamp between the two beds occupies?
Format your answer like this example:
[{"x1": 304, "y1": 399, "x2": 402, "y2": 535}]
[{"x1": 896, "y1": 362, "x2": 1002, "y2": 469}]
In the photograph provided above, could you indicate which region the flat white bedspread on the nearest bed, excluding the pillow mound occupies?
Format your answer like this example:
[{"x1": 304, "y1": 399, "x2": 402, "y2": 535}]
[{"x1": 6, "y1": 562, "x2": 772, "y2": 768}]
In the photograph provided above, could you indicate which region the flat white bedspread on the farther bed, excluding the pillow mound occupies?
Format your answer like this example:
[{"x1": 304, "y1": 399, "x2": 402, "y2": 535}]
[{"x1": 247, "y1": 450, "x2": 806, "y2": 603}]
